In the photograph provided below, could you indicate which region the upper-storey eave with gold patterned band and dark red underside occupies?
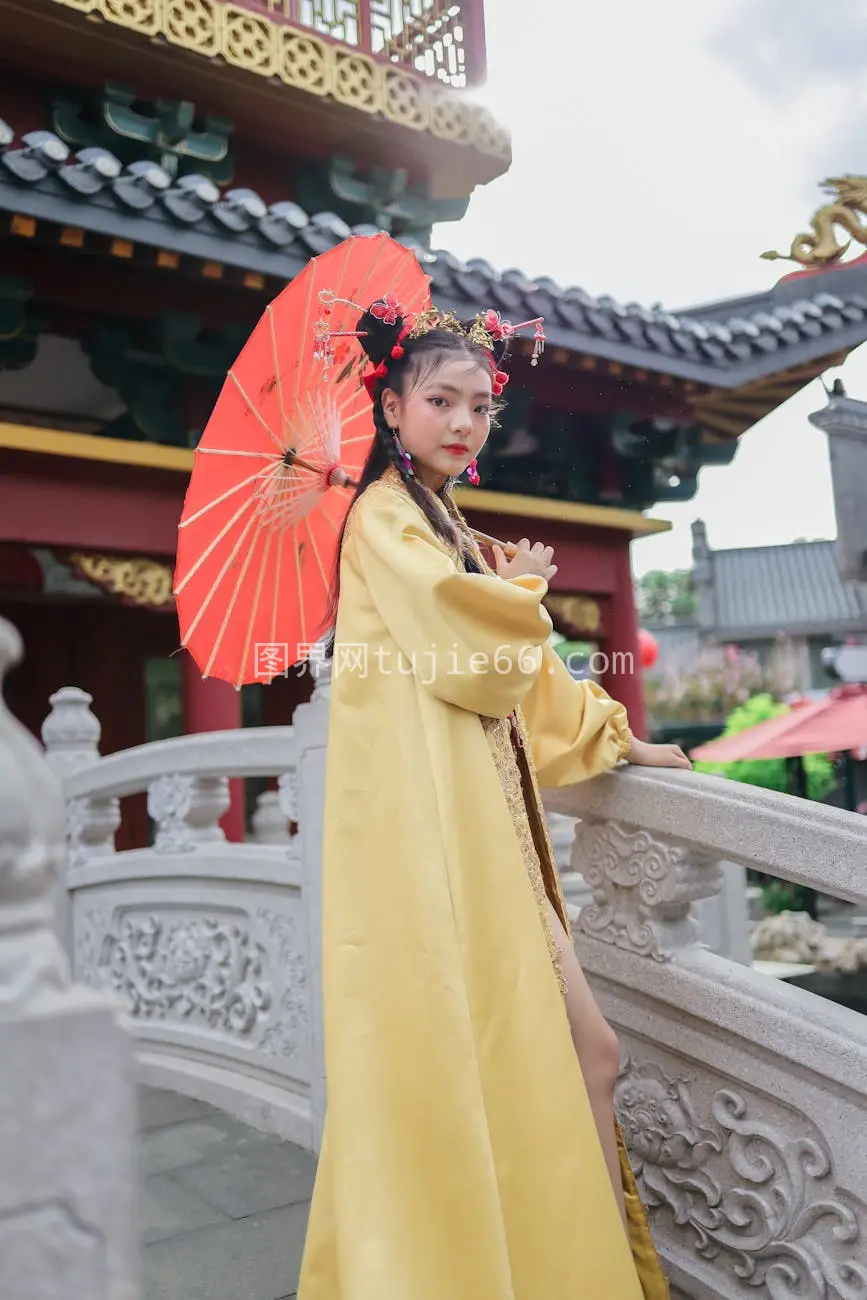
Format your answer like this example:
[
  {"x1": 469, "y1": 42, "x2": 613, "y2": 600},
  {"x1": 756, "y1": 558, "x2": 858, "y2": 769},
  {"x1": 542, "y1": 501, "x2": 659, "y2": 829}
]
[{"x1": 0, "y1": 0, "x2": 511, "y2": 198}]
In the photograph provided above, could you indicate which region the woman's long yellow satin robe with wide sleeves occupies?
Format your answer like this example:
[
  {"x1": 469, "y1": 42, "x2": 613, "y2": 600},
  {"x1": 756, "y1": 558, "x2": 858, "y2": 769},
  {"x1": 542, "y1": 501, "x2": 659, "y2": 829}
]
[{"x1": 299, "y1": 475, "x2": 668, "y2": 1300}]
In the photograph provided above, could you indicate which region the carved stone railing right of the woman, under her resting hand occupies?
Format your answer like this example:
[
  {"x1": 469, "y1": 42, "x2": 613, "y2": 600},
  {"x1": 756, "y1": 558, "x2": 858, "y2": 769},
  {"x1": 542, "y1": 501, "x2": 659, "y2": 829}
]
[{"x1": 546, "y1": 768, "x2": 867, "y2": 1300}]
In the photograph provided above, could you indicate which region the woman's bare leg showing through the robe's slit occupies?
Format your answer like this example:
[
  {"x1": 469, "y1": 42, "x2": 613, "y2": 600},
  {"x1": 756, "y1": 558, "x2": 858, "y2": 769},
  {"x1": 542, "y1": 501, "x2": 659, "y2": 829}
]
[{"x1": 549, "y1": 904, "x2": 627, "y2": 1229}]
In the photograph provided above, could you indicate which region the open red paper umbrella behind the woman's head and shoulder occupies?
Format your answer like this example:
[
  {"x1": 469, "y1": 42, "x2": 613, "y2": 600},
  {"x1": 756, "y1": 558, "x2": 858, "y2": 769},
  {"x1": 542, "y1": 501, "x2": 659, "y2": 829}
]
[{"x1": 174, "y1": 234, "x2": 430, "y2": 686}]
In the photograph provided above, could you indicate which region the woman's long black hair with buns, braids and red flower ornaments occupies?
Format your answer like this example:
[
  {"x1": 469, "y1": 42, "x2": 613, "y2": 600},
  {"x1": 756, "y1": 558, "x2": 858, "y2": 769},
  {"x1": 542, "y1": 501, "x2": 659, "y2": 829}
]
[{"x1": 322, "y1": 311, "x2": 506, "y2": 644}]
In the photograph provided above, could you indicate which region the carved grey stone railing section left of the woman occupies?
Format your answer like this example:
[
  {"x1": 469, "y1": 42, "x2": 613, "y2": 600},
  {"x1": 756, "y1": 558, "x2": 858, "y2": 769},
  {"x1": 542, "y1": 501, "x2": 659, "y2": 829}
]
[{"x1": 43, "y1": 676, "x2": 328, "y2": 1149}]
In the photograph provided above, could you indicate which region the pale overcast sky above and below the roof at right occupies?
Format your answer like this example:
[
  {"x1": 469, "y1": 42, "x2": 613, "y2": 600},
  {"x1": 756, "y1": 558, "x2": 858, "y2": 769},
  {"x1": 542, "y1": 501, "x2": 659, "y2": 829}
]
[{"x1": 434, "y1": 0, "x2": 867, "y2": 573}]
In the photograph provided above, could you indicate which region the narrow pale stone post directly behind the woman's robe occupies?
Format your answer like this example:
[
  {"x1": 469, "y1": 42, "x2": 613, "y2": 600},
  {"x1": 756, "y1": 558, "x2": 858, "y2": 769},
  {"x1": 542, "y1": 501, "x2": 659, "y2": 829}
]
[{"x1": 291, "y1": 660, "x2": 331, "y2": 1152}]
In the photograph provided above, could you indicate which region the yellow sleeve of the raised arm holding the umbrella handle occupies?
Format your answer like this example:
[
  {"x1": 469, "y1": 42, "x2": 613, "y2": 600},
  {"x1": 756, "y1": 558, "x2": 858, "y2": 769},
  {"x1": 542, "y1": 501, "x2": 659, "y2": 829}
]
[{"x1": 351, "y1": 491, "x2": 551, "y2": 718}]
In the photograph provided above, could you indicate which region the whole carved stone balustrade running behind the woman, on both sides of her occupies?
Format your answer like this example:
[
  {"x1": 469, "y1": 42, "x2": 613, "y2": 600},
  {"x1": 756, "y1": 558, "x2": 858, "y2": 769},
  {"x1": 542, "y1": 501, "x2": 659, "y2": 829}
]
[{"x1": 22, "y1": 650, "x2": 867, "y2": 1300}]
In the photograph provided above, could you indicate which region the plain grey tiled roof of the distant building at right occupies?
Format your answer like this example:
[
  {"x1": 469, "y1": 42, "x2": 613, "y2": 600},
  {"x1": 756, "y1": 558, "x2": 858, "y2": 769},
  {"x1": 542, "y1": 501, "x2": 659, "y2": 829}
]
[{"x1": 708, "y1": 542, "x2": 867, "y2": 638}]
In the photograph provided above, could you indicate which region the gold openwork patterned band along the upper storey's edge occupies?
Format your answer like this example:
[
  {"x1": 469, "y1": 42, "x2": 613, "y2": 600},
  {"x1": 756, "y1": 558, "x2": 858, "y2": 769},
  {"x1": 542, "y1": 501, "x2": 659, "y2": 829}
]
[{"x1": 53, "y1": 0, "x2": 511, "y2": 160}]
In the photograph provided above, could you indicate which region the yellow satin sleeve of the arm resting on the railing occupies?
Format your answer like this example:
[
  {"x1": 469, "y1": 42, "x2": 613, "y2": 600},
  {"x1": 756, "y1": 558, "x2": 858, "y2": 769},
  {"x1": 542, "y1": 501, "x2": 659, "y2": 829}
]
[{"x1": 521, "y1": 645, "x2": 632, "y2": 789}]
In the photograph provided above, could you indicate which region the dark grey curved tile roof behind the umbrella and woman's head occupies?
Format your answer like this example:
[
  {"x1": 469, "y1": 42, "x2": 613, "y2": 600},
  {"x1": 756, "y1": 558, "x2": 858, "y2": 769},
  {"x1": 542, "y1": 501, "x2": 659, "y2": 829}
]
[{"x1": 0, "y1": 121, "x2": 867, "y2": 387}]
